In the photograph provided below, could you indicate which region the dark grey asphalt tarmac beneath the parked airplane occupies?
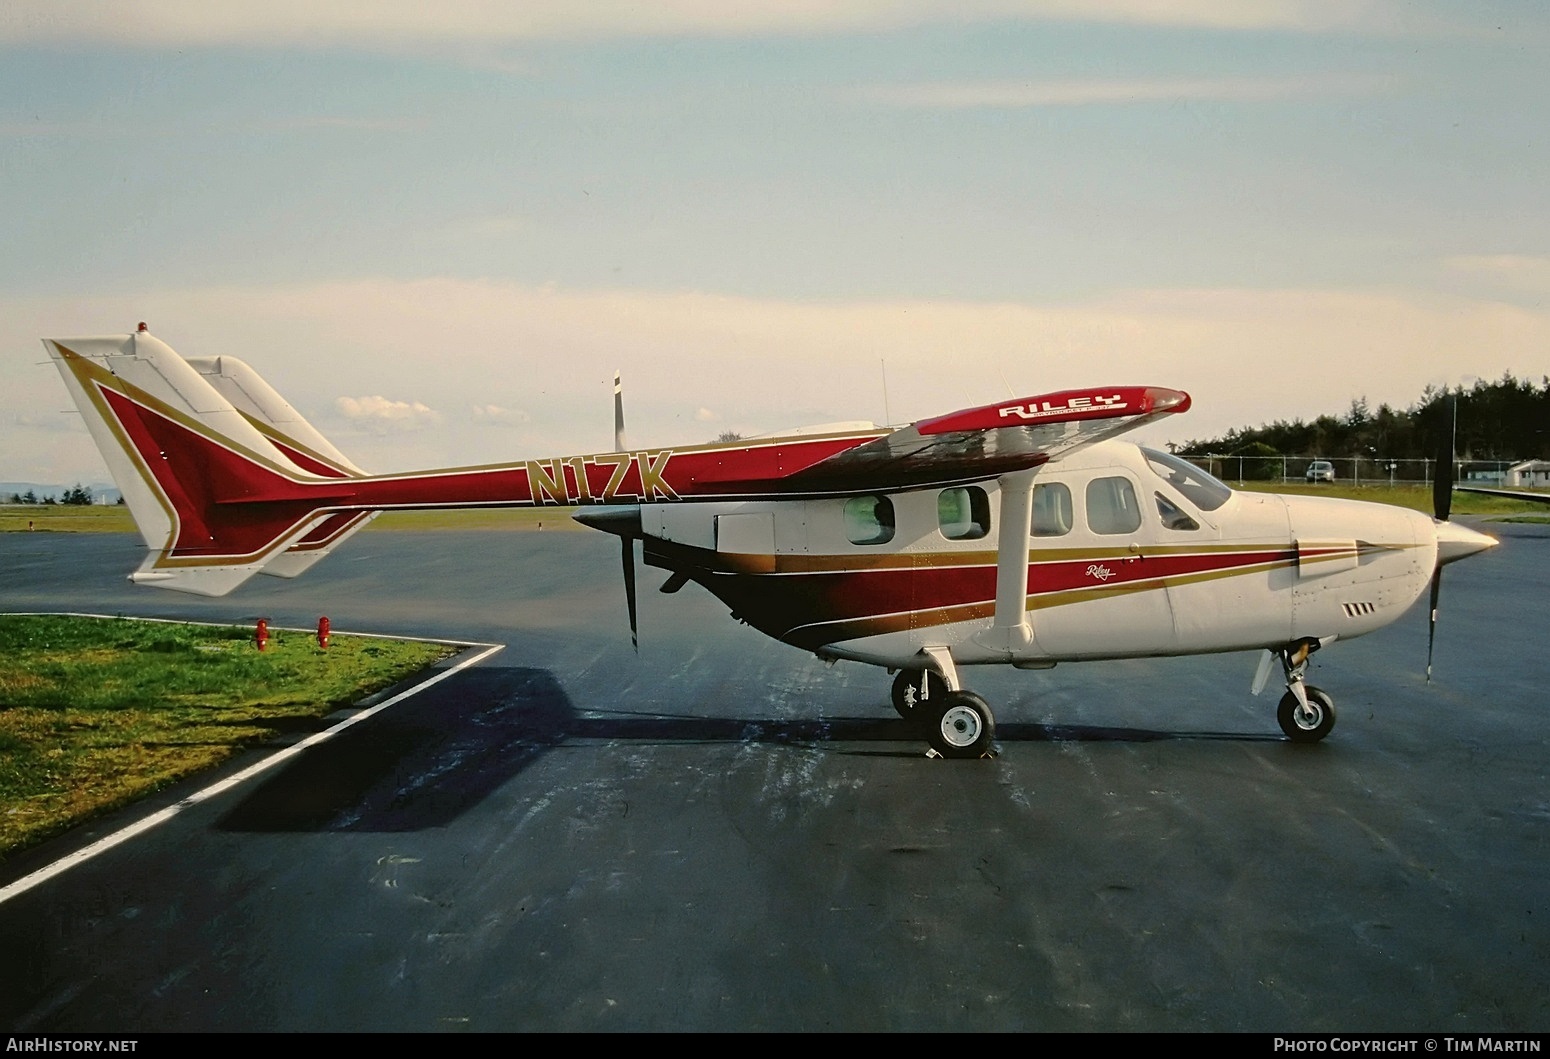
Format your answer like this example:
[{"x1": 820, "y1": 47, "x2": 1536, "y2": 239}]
[{"x1": 0, "y1": 526, "x2": 1550, "y2": 1034}]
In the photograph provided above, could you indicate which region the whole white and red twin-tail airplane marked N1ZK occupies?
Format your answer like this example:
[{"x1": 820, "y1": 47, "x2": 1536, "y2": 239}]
[{"x1": 43, "y1": 326, "x2": 1496, "y2": 757}]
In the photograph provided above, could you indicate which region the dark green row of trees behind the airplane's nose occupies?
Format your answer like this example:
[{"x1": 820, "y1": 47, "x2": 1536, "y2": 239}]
[{"x1": 1175, "y1": 374, "x2": 1550, "y2": 461}]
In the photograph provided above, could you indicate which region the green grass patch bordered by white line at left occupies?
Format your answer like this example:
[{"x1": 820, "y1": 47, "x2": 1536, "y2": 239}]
[{"x1": 0, "y1": 616, "x2": 454, "y2": 859}]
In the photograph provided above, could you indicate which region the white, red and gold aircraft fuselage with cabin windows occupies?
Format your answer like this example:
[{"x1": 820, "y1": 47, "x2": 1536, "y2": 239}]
[{"x1": 640, "y1": 442, "x2": 1437, "y2": 667}]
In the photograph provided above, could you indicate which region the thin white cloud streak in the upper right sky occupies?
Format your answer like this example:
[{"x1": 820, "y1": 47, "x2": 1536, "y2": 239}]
[{"x1": 857, "y1": 74, "x2": 1395, "y2": 110}]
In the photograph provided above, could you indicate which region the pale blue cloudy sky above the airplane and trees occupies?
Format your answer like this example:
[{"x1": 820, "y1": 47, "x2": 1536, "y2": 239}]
[{"x1": 0, "y1": 0, "x2": 1550, "y2": 484}]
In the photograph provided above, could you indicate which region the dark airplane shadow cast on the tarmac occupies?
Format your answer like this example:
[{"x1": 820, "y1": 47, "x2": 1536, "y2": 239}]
[{"x1": 217, "y1": 667, "x2": 1280, "y2": 833}]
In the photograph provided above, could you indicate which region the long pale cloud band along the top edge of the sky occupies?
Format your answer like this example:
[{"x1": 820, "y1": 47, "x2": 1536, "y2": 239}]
[{"x1": 0, "y1": 0, "x2": 1417, "y2": 50}]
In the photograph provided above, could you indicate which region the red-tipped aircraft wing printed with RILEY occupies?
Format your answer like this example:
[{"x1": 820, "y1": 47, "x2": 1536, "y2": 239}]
[{"x1": 768, "y1": 386, "x2": 1189, "y2": 493}]
